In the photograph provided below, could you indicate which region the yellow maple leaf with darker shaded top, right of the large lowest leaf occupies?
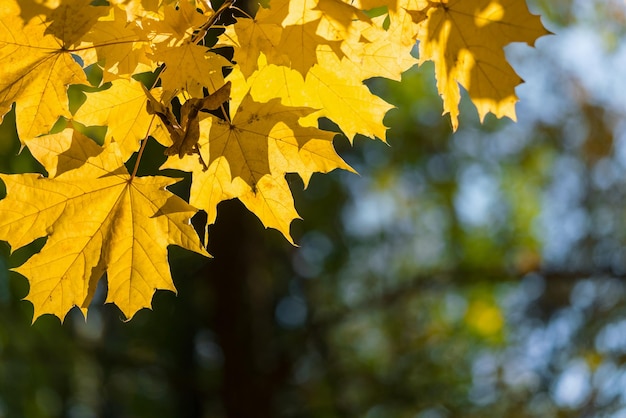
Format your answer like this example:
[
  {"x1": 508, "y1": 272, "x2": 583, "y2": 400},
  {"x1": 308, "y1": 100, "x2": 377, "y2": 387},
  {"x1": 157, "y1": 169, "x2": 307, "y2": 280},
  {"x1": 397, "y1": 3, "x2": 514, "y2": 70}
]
[{"x1": 162, "y1": 95, "x2": 354, "y2": 243}]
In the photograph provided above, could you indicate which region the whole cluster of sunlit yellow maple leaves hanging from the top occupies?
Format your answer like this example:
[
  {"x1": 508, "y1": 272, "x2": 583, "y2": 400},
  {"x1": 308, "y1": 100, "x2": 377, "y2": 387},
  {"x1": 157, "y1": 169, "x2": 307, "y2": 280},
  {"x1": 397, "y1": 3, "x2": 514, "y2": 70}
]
[{"x1": 0, "y1": 0, "x2": 547, "y2": 319}]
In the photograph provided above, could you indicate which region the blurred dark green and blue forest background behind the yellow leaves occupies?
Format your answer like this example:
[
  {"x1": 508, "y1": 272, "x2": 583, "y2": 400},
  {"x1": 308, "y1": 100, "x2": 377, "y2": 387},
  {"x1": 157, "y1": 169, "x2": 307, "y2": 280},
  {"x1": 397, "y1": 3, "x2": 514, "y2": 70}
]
[{"x1": 0, "y1": 0, "x2": 626, "y2": 418}]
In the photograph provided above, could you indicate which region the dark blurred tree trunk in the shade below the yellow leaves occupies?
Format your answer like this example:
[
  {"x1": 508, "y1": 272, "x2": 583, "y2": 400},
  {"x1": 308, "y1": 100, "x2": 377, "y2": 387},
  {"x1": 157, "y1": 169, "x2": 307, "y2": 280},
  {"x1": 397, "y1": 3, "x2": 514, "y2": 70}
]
[{"x1": 206, "y1": 201, "x2": 288, "y2": 418}]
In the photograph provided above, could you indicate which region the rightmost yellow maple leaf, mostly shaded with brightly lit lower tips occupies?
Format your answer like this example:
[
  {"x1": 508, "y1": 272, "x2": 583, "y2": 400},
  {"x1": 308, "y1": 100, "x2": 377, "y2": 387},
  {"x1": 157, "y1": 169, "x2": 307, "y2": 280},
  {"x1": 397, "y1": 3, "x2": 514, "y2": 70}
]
[{"x1": 419, "y1": 0, "x2": 549, "y2": 129}]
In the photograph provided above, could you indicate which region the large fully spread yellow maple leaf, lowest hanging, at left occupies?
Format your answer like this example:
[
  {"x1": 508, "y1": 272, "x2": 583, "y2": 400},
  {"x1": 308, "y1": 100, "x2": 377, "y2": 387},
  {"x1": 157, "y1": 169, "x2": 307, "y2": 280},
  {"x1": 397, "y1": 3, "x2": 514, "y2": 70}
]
[{"x1": 0, "y1": 134, "x2": 208, "y2": 320}]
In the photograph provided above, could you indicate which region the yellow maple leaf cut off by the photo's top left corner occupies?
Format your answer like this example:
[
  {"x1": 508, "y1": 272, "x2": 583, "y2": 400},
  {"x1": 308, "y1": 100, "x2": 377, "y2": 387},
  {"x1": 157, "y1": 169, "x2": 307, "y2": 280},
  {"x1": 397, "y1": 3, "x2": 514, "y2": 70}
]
[{"x1": 0, "y1": 0, "x2": 89, "y2": 142}]
